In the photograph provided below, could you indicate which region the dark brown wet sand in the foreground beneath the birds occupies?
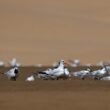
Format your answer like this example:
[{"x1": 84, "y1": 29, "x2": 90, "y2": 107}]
[{"x1": 0, "y1": 68, "x2": 110, "y2": 110}]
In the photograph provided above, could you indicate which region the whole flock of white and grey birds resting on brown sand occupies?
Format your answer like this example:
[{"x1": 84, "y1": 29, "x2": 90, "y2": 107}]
[{"x1": 0, "y1": 58, "x2": 110, "y2": 82}]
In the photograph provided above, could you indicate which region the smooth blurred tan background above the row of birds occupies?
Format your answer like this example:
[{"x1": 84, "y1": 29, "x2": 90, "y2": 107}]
[{"x1": 0, "y1": 0, "x2": 110, "y2": 65}]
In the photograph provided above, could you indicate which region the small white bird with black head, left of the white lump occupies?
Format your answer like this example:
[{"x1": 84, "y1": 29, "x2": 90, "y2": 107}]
[{"x1": 3, "y1": 67, "x2": 19, "y2": 80}]
